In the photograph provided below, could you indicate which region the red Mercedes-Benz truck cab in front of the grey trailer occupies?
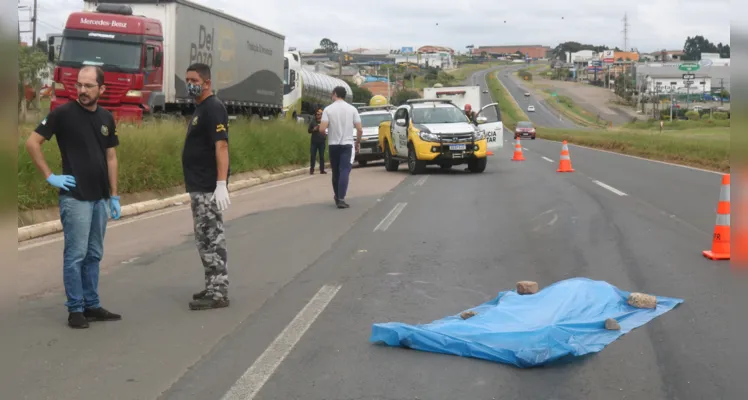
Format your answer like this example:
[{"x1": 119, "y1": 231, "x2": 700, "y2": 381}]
[{"x1": 48, "y1": 4, "x2": 164, "y2": 121}]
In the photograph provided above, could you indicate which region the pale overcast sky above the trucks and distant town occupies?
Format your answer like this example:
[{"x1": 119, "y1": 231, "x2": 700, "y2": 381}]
[{"x1": 18, "y1": 0, "x2": 732, "y2": 52}]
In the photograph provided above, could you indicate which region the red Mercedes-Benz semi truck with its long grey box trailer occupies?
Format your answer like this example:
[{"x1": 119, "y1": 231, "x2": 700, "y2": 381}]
[{"x1": 49, "y1": 0, "x2": 285, "y2": 120}]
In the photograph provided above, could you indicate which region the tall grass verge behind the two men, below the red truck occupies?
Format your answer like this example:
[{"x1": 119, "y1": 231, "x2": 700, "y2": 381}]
[{"x1": 18, "y1": 120, "x2": 316, "y2": 211}]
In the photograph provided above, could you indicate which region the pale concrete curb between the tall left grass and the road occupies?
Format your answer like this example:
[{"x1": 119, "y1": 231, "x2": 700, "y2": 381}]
[{"x1": 18, "y1": 164, "x2": 316, "y2": 243}]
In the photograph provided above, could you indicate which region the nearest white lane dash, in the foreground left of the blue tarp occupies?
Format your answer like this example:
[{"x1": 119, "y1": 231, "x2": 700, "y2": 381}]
[{"x1": 222, "y1": 285, "x2": 340, "y2": 400}]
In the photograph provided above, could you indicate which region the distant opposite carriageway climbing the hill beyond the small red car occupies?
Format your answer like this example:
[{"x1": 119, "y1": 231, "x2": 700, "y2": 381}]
[{"x1": 498, "y1": 67, "x2": 582, "y2": 129}]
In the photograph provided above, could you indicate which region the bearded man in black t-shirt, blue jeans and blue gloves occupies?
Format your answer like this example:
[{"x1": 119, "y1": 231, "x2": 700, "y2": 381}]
[{"x1": 26, "y1": 67, "x2": 121, "y2": 328}]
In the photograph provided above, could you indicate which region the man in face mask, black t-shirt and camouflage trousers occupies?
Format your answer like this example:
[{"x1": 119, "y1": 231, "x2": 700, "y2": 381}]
[{"x1": 182, "y1": 64, "x2": 231, "y2": 310}]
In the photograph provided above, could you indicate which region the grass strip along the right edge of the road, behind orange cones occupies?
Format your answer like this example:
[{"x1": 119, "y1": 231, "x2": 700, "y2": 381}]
[{"x1": 538, "y1": 128, "x2": 730, "y2": 172}]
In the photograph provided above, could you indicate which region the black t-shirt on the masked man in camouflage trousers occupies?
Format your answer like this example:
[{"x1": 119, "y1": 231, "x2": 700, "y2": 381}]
[{"x1": 182, "y1": 96, "x2": 229, "y2": 193}]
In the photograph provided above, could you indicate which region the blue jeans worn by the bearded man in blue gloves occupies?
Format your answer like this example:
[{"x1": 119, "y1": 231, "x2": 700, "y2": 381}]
[{"x1": 60, "y1": 195, "x2": 109, "y2": 313}]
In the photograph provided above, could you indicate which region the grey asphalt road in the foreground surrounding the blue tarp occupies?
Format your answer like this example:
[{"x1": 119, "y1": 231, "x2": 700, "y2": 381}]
[{"x1": 18, "y1": 68, "x2": 748, "y2": 400}]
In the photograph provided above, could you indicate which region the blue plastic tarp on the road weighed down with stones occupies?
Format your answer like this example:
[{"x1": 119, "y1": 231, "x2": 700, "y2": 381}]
[{"x1": 370, "y1": 278, "x2": 683, "y2": 368}]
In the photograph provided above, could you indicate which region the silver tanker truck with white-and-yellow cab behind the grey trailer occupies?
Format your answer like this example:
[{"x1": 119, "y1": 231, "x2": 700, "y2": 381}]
[{"x1": 283, "y1": 50, "x2": 353, "y2": 120}]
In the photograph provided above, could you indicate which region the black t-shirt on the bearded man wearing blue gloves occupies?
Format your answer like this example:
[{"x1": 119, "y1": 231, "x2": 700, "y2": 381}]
[{"x1": 36, "y1": 101, "x2": 119, "y2": 201}]
